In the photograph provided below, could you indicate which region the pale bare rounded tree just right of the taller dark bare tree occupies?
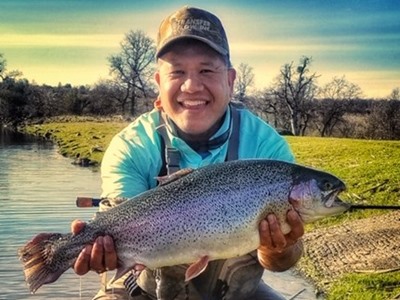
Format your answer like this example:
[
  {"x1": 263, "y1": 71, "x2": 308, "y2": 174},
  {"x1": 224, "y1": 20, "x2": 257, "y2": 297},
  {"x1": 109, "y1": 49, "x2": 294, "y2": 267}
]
[{"x1": 315, "y1": 76, "x2": 362, "y2": 137}]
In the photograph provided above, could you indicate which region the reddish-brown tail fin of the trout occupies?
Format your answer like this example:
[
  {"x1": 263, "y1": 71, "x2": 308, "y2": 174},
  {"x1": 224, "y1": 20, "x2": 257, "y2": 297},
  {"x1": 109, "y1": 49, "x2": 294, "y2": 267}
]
[{"x1": 18, "y1": 233, "x2": 69, "y2": 294}]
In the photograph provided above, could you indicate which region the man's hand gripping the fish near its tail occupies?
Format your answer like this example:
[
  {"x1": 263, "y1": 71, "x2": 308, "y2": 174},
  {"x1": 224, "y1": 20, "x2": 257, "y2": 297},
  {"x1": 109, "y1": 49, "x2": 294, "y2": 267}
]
[{"x1": 71, "y1": 220, "x2": 117, "y2": 275}]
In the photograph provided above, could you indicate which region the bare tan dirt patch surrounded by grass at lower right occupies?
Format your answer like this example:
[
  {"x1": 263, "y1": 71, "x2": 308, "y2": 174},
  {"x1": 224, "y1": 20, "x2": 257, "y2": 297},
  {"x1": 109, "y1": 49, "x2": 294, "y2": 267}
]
[{"x1": 304, "y1": 211, "x2": 400, "y2": 281}]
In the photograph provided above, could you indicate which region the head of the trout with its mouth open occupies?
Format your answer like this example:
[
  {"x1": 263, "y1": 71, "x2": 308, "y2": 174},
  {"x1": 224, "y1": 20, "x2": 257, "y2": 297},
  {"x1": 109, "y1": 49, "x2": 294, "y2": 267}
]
[{"x1": 289, "y1": 168, "x2": 350, "y2": 223}]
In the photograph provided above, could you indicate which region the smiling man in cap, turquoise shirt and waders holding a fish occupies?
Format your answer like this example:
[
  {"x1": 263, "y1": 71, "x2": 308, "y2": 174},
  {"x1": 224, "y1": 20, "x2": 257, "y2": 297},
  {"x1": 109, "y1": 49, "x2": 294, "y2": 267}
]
[{"x1": 72, "y1": 7, "x2": 304, "y2": 299}]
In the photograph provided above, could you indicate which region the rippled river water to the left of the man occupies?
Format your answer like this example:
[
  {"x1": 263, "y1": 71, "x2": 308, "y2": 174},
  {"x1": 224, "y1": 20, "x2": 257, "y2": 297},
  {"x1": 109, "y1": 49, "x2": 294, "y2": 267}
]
[{"x1": 0, "y1": 131, "x2": 101, "y2": 299}]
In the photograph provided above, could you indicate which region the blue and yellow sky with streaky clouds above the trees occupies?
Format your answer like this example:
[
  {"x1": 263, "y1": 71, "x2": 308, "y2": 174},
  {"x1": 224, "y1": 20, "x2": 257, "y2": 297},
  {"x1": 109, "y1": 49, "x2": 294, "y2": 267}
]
[{"x1": 0, "y1": 0, "x2": 400, "y2": 98}]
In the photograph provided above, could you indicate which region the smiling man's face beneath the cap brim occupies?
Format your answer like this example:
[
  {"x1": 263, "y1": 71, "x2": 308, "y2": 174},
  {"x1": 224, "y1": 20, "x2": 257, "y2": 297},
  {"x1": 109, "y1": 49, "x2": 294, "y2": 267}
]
[{"x1": 155, "y1": 41, "x2": 236, "y2": 139}]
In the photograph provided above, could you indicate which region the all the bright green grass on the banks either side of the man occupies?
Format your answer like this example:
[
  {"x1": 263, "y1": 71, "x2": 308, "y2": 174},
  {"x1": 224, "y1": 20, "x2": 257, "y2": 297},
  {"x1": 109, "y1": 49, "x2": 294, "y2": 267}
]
[{"x1": 19, "y1": 120, "x2": 400, "y2": 299}]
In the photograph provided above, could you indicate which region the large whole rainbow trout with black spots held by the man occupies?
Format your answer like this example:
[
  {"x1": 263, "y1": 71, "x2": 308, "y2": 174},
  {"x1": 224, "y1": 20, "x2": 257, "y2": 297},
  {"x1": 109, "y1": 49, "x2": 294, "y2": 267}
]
[{"x1": 19, "y1": 159, "x2": 349, "y2": 293}]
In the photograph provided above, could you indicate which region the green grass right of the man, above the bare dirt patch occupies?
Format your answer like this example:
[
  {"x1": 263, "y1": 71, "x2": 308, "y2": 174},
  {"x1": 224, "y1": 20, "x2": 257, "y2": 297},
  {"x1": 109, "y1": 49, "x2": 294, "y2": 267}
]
[{"x1": 287, "y1": 137, "x2": 400, "y2": 226}]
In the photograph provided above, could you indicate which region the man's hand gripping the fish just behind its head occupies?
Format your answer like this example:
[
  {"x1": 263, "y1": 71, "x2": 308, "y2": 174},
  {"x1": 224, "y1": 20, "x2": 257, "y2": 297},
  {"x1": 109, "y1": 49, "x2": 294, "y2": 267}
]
[{"x1": 258, "y1": 210, "x2": 304, "y2": 271}]
